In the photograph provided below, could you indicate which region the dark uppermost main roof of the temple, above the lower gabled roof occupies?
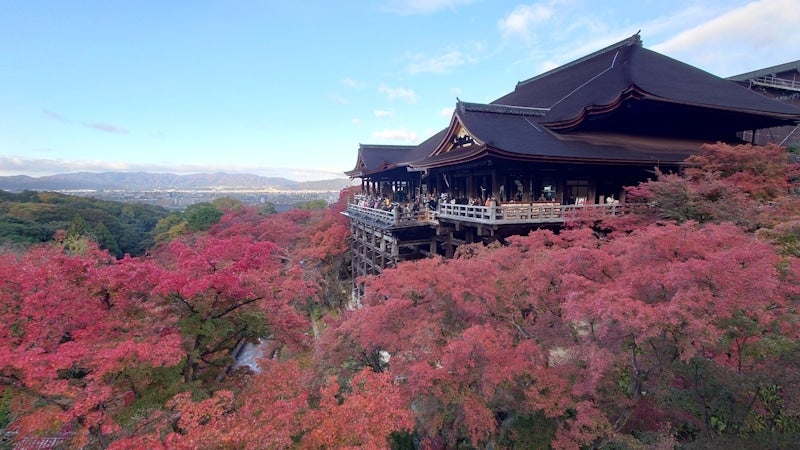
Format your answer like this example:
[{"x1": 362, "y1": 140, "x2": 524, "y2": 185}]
[{"x1": 493, "y1": 34, "x2": 800, "y2": 126}]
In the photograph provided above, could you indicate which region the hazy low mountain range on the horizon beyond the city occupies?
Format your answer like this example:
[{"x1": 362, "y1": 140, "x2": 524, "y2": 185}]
[{"x1": 0, "y1": 172, "x2": 349, "y2": 192}]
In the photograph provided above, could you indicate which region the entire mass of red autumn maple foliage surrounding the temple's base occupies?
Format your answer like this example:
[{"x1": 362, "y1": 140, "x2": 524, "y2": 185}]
[{"x1": 0, "y1": 144, "x2": 800, "y2": 449}]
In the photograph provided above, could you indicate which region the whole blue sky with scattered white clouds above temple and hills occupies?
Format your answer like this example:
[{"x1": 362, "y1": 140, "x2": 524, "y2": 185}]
[{"x1": 0, "y1": 0, "x2": 800, "y2": 181}]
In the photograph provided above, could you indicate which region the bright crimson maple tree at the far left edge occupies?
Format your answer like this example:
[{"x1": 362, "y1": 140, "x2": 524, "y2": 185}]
[{"x1": 0, "y1": 245, "x2": 181, "y2": 442}]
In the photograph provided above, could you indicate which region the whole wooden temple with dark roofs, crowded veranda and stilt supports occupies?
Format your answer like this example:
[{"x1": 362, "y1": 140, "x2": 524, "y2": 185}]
[{"x1": 345, "y1": 34, "x2": 800, "y2": 294}]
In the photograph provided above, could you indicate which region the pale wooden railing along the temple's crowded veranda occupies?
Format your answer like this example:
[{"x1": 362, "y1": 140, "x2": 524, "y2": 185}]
[{"x1": 346, "y1": 197, "x2": 627, "y2": 227}]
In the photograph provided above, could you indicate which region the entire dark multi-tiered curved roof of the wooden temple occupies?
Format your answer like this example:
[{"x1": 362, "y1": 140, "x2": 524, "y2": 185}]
[{"x1": 347, "y1": 34, "x2": 800, "y2": 176}]
